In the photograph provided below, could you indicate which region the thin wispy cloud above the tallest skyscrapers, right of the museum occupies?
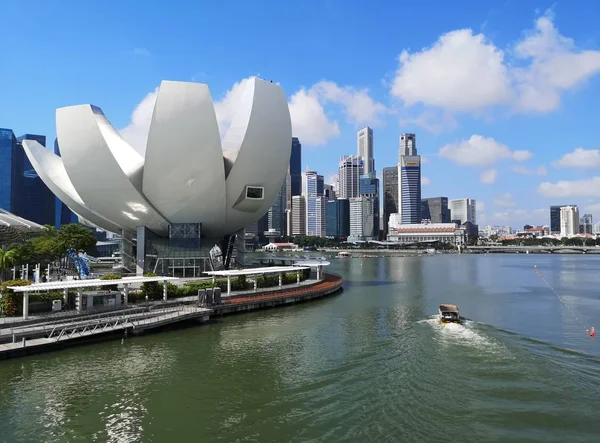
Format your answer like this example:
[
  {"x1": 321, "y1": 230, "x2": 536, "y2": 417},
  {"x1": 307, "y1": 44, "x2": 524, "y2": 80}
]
[{"x1": 311, "y1": 81, "x2": 388, "y2": 125}]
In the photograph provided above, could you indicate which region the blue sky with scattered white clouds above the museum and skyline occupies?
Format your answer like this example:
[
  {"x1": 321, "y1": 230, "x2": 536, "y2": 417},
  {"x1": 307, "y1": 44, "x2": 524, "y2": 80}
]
[{"x1": 0, "y1": 0, "x2": 600, "y2": 227}]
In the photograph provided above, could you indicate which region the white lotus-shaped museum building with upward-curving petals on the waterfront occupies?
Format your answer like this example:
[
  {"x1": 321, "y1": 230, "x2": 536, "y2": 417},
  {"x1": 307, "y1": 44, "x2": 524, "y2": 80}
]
[{"x1": 23, "y1": 78, "x2": 292, "y2": 277}]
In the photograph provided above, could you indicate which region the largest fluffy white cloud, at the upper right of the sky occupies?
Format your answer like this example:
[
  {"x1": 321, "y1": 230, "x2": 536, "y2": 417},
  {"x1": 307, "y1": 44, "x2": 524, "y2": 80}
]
[{"x1": 391, "y1": 12, "x2": 600, "y2": 113}]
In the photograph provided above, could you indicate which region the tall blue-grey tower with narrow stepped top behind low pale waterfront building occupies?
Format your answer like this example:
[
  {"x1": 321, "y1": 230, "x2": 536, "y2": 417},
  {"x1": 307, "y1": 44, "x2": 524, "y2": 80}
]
[{"x1": 398, "y1": 134, "x2": 421, "y2": 224}]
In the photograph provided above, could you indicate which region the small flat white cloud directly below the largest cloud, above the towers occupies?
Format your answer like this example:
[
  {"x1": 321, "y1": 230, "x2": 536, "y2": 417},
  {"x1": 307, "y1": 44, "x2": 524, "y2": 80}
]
[{"x1": 439, "y1": 134, "x2": 533, "y2": 167}]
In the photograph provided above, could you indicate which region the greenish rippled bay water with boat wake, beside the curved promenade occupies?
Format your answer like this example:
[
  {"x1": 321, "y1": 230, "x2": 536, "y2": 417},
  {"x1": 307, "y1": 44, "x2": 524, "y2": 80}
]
[{"x1": 0, "y1": 254, "x2": 600, "y2": 443}]
